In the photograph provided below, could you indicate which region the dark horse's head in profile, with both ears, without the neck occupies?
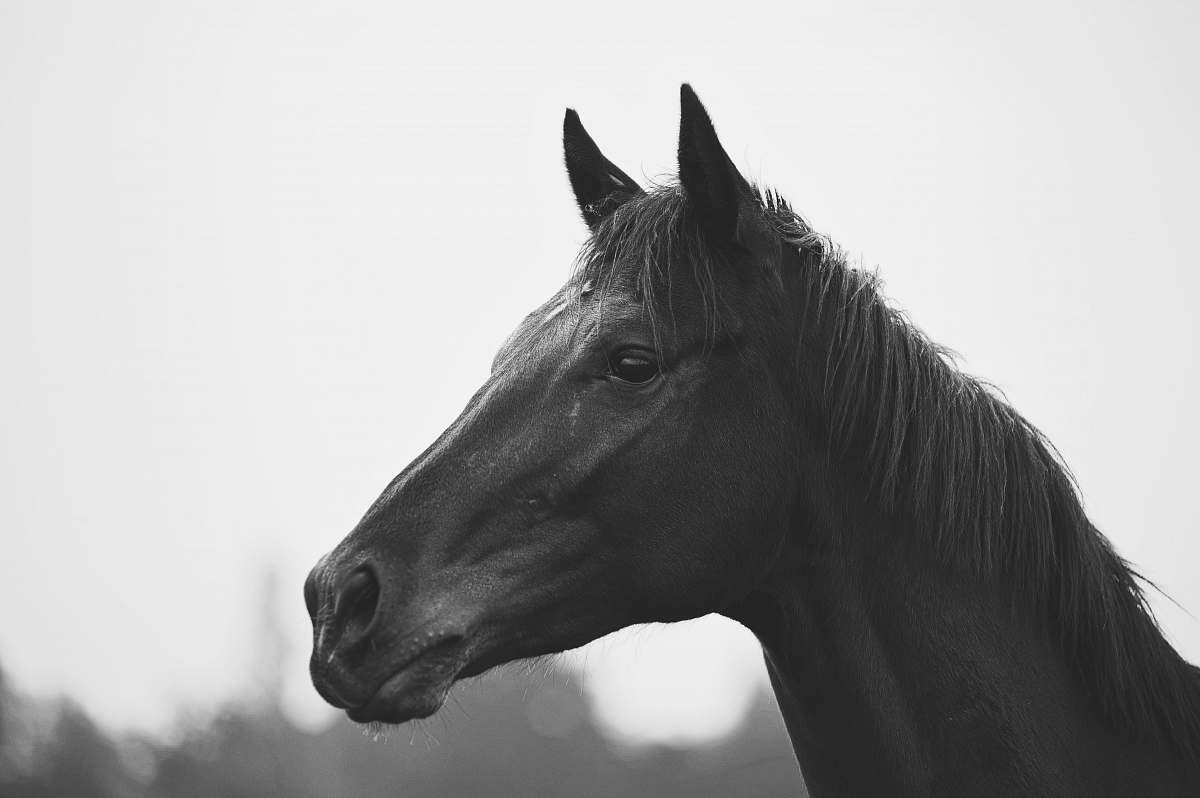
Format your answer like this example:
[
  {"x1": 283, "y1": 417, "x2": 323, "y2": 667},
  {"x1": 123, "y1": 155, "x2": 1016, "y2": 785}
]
[{"x1": 305, "y1": 85, "x2": 803, "y2": 722}]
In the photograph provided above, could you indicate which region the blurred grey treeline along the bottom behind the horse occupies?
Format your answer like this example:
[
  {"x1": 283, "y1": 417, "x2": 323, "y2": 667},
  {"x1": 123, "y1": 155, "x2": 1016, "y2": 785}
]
[{"x1": 0, "y1": 668, "x2": 805, "y2": 798}]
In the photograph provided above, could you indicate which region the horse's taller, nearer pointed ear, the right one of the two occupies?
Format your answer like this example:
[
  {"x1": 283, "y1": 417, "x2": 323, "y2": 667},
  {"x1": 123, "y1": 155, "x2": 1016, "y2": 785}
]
[{"x1": 679, "y1": 83, "x2": 750, "y2": 242}]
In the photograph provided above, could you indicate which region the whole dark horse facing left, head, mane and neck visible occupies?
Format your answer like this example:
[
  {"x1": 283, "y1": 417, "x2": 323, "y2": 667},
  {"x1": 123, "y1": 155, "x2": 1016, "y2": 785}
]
[{"x1": 305, "y1": 84, "x2": 1200, "y2": 797}]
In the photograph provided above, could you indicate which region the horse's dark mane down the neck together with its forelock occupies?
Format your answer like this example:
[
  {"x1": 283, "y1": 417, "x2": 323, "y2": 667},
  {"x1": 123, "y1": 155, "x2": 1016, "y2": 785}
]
[{"x1": 577, "y1": 185, "x2": 1200, "y2": 767}]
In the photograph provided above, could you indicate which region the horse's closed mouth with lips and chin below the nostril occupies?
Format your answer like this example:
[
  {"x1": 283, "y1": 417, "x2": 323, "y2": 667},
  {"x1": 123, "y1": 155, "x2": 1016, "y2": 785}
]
[{"x1": 346, "y1": 635, "x2": 469, "y2": 724}]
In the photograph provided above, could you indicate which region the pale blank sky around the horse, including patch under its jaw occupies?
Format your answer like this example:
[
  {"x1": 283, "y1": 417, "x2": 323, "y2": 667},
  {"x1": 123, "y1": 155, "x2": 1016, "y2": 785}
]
[{"x1": 0, "y1": 0, "x2": 1200, "y2": 744}]
